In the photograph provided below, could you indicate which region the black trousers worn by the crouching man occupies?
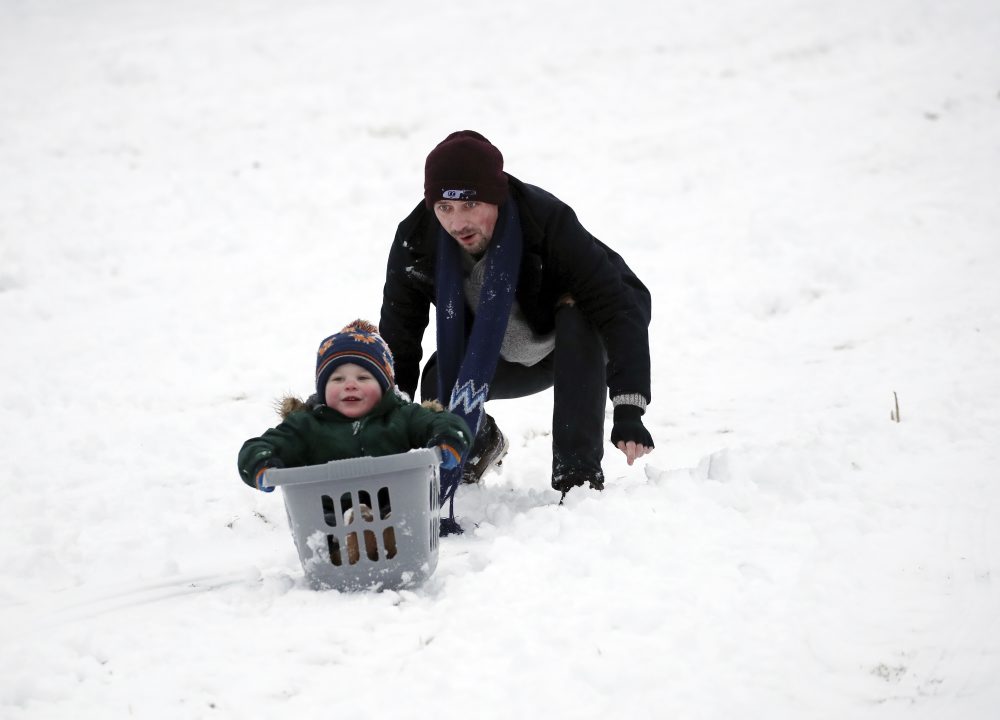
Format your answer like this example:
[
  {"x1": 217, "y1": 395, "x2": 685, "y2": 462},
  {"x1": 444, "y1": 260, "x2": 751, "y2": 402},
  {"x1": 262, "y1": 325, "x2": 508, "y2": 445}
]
[{"x1": 420, "y1": 305, "x2": 608, "y2": 481}]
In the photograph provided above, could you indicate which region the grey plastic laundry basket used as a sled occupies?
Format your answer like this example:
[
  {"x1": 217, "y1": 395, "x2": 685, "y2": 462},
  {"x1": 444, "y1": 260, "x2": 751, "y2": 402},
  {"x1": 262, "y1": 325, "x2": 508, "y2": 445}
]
[{"x1": 266, "y1": 448, "x2": 441, "y2": 590}]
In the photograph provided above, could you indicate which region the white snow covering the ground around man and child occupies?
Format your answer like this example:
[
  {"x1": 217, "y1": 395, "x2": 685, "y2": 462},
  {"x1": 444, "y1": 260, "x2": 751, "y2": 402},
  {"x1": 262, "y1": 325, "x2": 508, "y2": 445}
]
[{"x1": 0, "y1": 0, "x2": 1000, "y2": 720}]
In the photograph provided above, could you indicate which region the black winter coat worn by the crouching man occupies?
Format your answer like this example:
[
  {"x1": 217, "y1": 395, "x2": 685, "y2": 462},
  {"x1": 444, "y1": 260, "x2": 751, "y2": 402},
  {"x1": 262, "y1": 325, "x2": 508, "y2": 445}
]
[{"x1": 379, "y1": 175, "x2": 652, "y2": 401}]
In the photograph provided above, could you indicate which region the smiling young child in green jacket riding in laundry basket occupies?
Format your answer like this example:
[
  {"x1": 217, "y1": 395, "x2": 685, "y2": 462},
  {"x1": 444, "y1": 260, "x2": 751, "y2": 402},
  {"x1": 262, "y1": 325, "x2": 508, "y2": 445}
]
[{"x1": 237, "y1": 320, "x2": 471, "y2": 492}]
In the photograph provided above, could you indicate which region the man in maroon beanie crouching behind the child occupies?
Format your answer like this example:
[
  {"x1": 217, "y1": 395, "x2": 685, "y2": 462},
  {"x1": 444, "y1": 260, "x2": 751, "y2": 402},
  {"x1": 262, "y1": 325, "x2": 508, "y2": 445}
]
[{"x1": 379, "y1": 130, "x2": 653, "y2": 497}]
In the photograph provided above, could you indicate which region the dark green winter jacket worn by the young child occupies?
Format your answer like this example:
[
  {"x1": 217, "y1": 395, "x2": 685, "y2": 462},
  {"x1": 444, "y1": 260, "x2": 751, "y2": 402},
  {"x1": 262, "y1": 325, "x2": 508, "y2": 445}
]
[{"x1": 237, "y1": 392, "x2": 471, "y2": 487}]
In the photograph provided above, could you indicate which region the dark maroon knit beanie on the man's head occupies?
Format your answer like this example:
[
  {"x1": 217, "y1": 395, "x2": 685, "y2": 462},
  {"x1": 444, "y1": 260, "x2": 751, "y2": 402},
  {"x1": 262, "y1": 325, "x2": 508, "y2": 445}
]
[{"x1": 424, "y1": 130, "x2": 507, "y2": 208}]
